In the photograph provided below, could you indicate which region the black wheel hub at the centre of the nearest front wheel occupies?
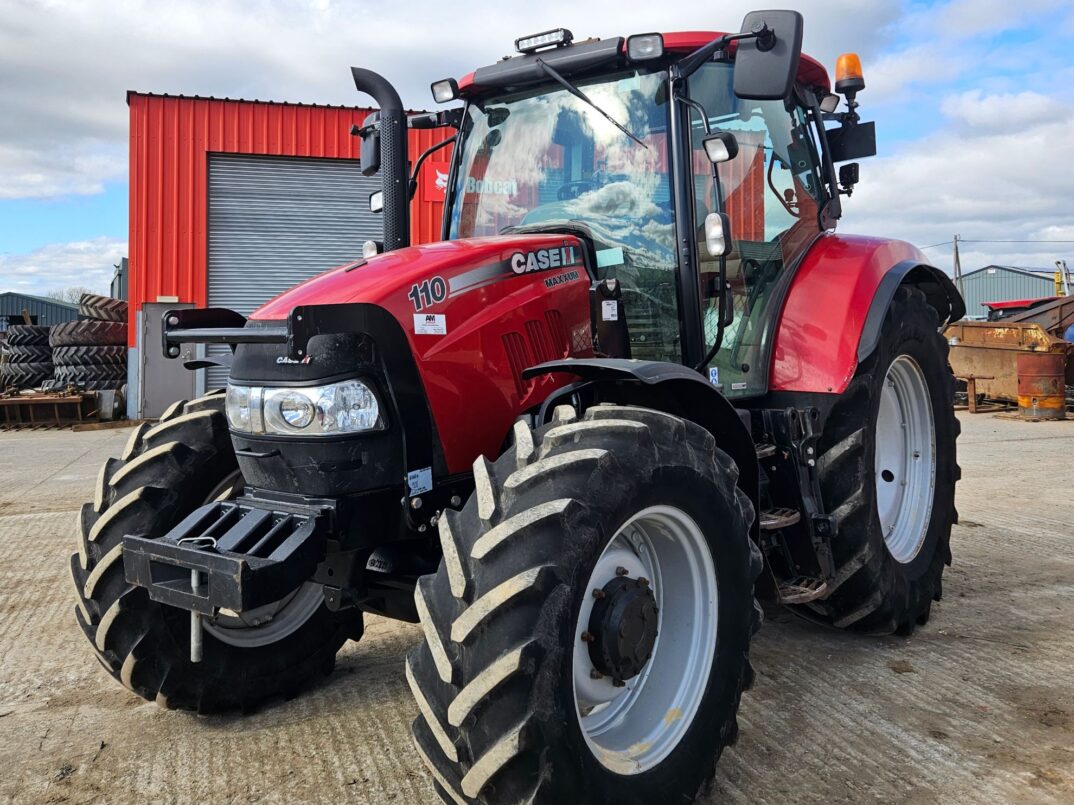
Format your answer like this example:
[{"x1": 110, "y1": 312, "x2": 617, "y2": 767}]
[{"x1": 587, "y1": 575, "x2": 657, "y2": 682}]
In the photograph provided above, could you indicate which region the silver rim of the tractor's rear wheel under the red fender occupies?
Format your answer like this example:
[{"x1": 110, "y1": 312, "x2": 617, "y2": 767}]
[{"x1": 874, "y1": 355, "x2": 937, "y2": 565}]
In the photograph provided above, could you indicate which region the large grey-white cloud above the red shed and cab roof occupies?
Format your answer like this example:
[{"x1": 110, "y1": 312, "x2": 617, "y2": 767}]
[{"x1": 0, "y1": 0, "x2": 902, "y2": 197}]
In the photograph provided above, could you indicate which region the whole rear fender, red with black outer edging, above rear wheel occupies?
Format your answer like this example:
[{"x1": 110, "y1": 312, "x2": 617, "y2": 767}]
[{"x1": 769, "y1": 235, "x2": 966, "y2": 394}]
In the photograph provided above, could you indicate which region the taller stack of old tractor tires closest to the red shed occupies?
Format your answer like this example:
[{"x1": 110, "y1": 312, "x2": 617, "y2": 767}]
[{"x1": 48, "y1": 293, "x2": 127, "y2": 392}]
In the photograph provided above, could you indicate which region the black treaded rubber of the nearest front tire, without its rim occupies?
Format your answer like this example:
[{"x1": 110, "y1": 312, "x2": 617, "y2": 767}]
[{"x1": 406, "y1": 406, "x2": 761, "y2": 803}]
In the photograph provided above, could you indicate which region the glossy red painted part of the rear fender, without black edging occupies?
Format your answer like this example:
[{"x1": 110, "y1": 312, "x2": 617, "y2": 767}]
[{"x1": 769, "y1": 234, "x2": 928, "y2": 394}]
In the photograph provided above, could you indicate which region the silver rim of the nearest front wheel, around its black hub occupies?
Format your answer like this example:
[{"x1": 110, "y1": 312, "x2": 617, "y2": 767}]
[{"x1": 572, "y1": 506, "x2": 719, "y2": 774}]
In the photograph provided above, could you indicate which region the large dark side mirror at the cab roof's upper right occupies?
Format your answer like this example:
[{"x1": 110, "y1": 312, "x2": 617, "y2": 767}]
[{"x1": 735, "y1": 11, "x2": 802, "y2": 101}]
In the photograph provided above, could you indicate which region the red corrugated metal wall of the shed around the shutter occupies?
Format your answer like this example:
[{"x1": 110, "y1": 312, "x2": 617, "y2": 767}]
[{"x1": 127, "y1": 92, "x2": 450, "y2": 346}]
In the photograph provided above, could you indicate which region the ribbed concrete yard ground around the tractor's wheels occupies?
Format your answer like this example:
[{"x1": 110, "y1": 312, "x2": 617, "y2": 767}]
[{"x1": 0, "y1": 414, "x2": 1074, "y2": 805}]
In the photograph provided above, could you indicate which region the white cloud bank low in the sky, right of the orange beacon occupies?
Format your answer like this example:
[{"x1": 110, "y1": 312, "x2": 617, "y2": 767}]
[{"x1": 844, "y1": 86, "x2": 1074, "y2": 267}]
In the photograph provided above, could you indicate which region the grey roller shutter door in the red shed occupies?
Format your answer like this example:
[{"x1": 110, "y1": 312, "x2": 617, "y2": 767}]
[{"x1": 206, "y1": 153, "x2": 383, "y2": 389}]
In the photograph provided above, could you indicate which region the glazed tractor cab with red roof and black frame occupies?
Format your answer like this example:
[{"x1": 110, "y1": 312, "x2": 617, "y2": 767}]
[{"x1": 421, "y1": 18, "x2": 872, "y2": 397}]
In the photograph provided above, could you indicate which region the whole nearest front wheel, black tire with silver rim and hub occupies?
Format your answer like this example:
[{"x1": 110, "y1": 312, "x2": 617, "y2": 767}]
[{"x1": 406, "y1": 406, "x2": 761, "y2": 804}]
